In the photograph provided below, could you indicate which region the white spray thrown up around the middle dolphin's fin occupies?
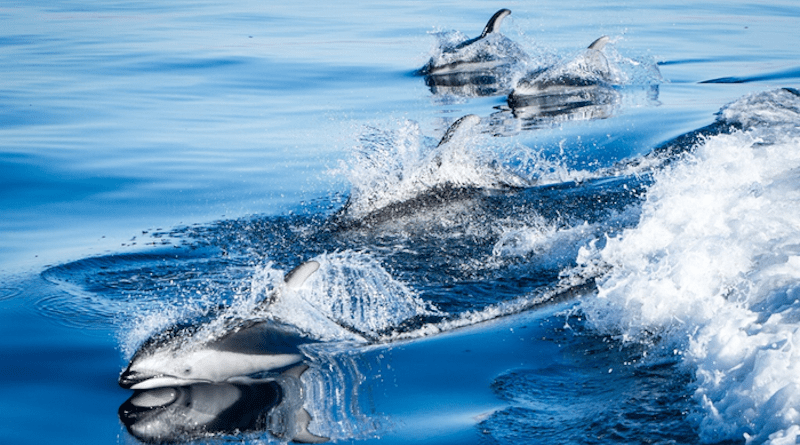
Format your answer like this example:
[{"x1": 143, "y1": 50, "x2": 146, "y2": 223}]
[{"x1": 331, "y1": 118, "x2": 590, "y2": 220}]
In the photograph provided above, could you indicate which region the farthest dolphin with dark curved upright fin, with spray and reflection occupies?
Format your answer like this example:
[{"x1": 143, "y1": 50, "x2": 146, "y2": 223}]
[{"x1": 417, "y1": 9, "x2": 528, "y2": 96}]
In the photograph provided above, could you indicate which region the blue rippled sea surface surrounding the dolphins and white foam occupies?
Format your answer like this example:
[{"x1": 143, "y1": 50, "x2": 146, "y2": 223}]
[{"x1": 0, "y1": 1, "x2": 800, "y2": 444}]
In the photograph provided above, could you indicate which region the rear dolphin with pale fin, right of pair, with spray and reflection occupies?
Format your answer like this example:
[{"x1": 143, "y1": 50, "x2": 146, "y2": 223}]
[{"x1": 508, "y1": 36, "x2": 619, "y2": 122}]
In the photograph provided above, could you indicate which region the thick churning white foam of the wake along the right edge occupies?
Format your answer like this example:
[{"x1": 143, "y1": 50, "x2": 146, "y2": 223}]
[{"x1": 579, "y1": 99, "x2": 800, "y2": 444}]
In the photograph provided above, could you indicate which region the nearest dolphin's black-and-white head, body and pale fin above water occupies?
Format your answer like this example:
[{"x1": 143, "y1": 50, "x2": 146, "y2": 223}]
[{"x1": 119, "y1": 261, "x2": 319, "y2": 390}]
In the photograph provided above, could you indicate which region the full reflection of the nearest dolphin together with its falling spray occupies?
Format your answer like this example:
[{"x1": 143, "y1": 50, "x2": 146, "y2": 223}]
[{"x1": 118, "y1": 344, "x2": 396, "y2": 443}]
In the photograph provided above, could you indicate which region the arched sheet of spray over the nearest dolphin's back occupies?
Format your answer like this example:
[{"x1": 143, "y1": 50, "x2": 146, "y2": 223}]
[{"x1": 120, "y1": 251, "x2": 440, "y2": 357}]
